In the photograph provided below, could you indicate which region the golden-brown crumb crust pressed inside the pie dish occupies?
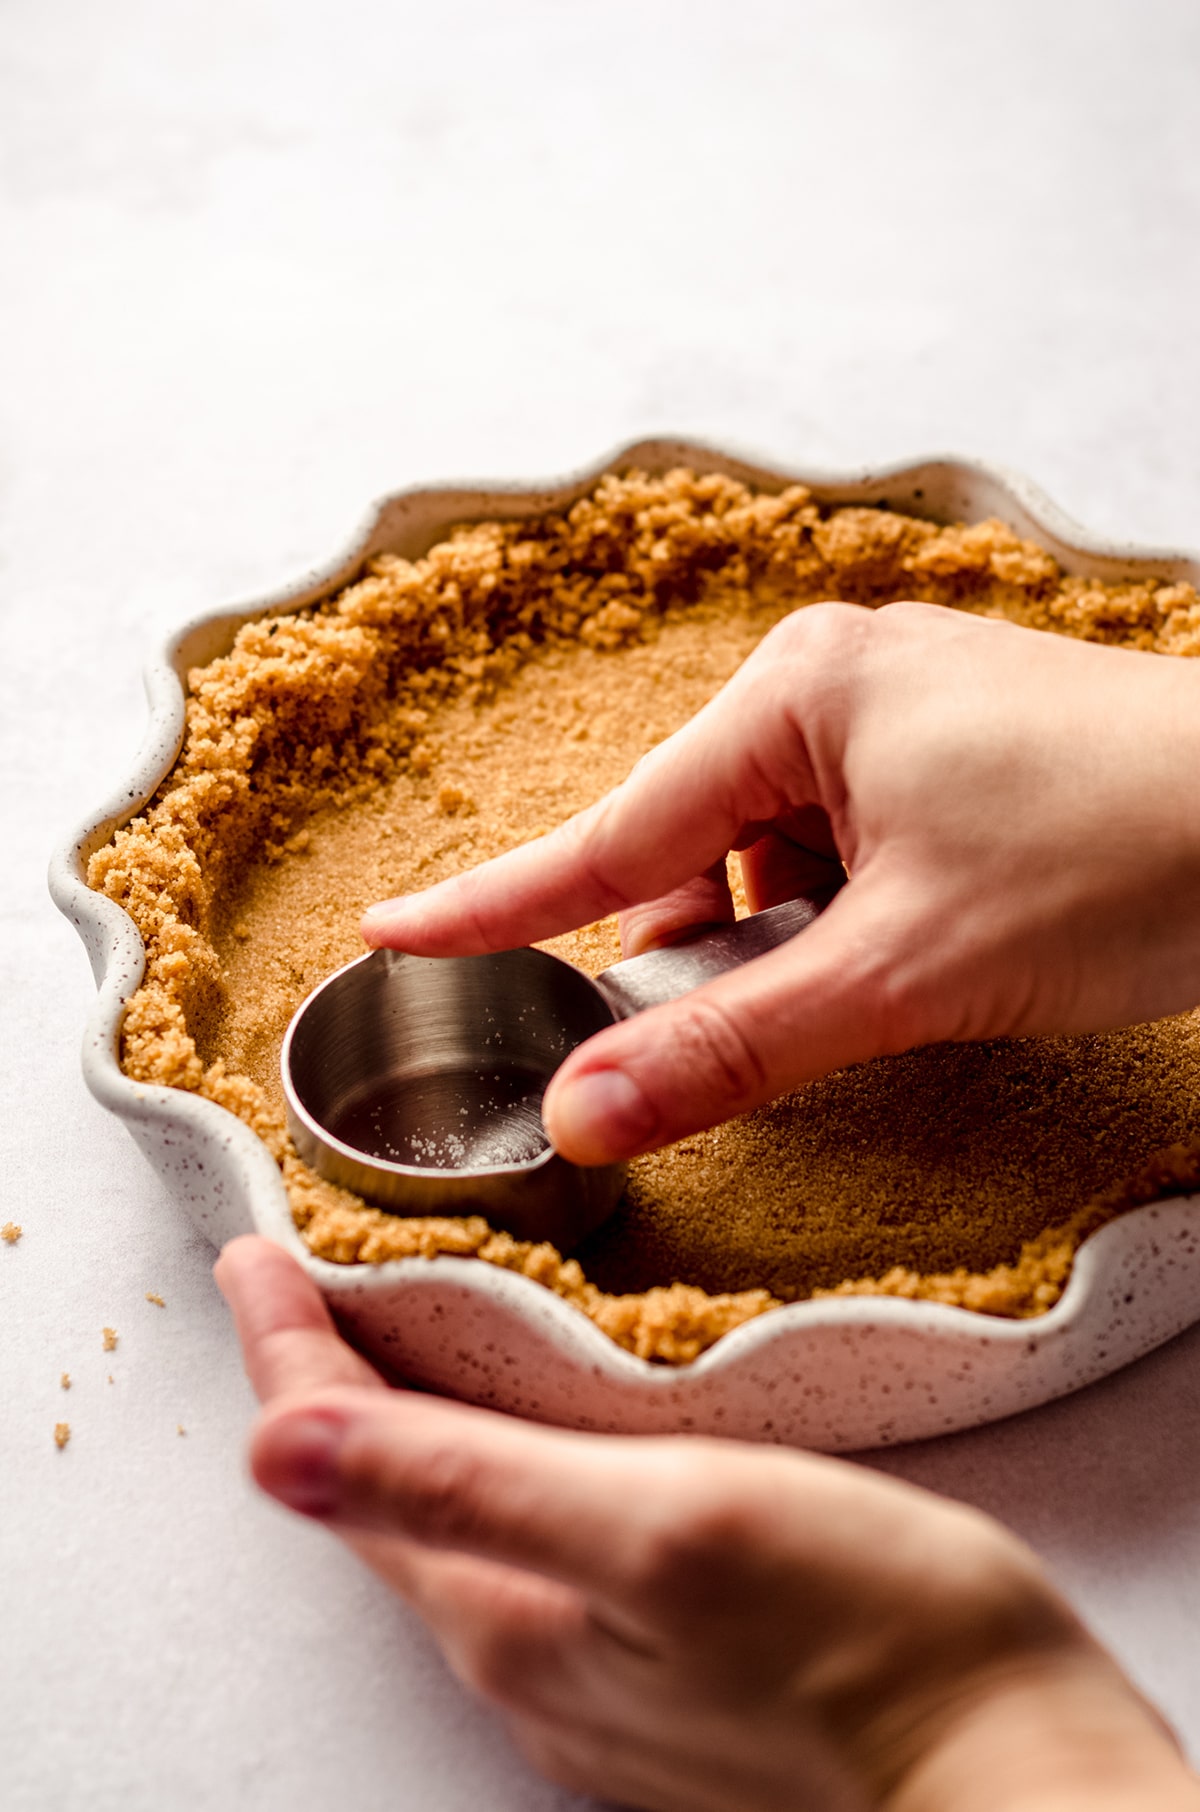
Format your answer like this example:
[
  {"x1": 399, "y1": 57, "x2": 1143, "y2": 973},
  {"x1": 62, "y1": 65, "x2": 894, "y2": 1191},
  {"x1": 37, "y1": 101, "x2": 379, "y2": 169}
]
[{"x1": 89, "y1": 471, "x2": 1200, "y2": 1363}]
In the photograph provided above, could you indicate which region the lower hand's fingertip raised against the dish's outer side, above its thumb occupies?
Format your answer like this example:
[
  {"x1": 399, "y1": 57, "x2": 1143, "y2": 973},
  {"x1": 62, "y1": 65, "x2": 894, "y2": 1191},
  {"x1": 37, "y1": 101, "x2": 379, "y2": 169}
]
[{"x1": 214, "y1": 1236, "x2": 384, "y2": 1402}]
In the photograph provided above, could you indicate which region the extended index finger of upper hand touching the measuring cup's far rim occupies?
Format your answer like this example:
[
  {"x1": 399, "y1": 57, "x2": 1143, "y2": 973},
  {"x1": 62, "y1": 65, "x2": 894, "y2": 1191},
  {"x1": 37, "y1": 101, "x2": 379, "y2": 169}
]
[{"x1": 363, "y1": 603, "x2": 870, "y2": 957}]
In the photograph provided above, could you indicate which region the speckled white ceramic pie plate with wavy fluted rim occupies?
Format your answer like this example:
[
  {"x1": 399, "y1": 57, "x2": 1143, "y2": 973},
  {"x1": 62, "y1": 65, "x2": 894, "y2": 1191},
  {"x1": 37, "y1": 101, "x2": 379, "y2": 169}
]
[{"x1": 51, "y1": 440, "x2": 1200, "y2": 1451}]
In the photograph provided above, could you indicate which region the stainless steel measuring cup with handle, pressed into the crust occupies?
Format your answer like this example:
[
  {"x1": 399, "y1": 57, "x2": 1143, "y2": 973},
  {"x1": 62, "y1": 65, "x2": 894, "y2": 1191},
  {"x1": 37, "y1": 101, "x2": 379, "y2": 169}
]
[{"x1": 281, "y1": 899, "x2": 821, "y2": 1250}]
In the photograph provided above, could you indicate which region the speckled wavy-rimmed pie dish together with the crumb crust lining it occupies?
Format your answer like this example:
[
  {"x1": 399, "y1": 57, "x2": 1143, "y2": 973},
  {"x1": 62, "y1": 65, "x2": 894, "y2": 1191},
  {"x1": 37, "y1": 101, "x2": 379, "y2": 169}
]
[{"x1": 53, "y1": 442, "x2": 1200, "y2": 1450}]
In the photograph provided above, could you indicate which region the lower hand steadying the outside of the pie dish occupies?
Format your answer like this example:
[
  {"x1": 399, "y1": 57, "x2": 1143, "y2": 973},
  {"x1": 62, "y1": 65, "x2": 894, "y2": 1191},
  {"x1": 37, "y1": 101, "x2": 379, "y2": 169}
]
[{"x1": 218, "y1": 1239, "x2": 1200, "y2": 1812}]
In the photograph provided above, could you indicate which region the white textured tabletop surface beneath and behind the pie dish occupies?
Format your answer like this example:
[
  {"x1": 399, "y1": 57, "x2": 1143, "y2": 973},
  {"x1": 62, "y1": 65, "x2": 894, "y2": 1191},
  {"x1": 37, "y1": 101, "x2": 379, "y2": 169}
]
[{"x1": 0, "y1": 0, "x2": 1200, "y2": 1812}]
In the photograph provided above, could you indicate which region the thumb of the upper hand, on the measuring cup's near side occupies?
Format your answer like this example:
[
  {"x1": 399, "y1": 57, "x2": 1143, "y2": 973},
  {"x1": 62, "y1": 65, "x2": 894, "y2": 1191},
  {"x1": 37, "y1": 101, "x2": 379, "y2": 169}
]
[{"x1": 542, "y1": 872, "x2": 948, "y2": 1165}]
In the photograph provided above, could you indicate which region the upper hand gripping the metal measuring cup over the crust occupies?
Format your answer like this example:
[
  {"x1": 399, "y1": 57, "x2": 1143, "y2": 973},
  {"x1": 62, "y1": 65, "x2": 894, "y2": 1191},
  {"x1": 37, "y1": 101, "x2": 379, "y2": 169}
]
[{"x1": 363, "y1": 603, "x2": 1200, "y2": 1163}]
